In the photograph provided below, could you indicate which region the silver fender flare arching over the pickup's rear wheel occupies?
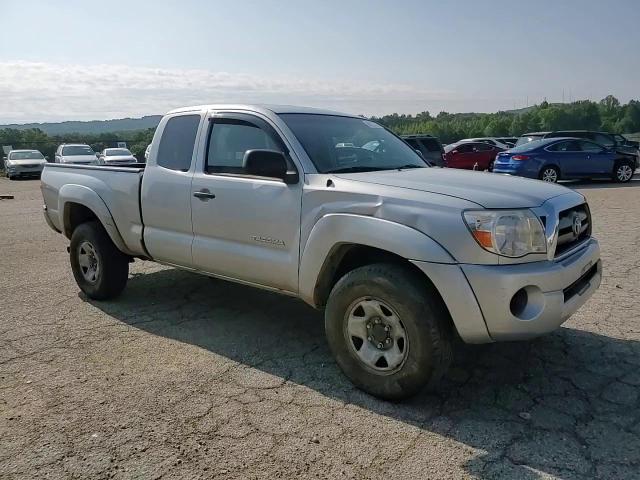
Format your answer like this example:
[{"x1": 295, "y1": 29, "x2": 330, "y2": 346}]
[{"x1": 58, "y1": 184, "x2": 131, "y2": 255}]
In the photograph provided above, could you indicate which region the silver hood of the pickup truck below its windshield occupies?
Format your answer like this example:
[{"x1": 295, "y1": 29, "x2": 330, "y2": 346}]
[{"x1": 336, "y1": 168, "x2": 578, "y2": 208}]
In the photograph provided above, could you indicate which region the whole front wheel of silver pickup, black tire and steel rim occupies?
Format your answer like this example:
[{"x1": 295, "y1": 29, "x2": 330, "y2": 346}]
[{"x1": 325, "y1": 264, "x2": 452, "y2": 400}]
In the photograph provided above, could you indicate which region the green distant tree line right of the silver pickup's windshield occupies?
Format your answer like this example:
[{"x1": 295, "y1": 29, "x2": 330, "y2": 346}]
[{"x1": 373, "y1": 95, "x2": 640, "y2": 143}]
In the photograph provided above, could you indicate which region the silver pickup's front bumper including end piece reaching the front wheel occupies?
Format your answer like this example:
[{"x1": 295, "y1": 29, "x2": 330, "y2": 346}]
[{"x1": 412, "y1": 238, "x2": 602, "y2": 343}]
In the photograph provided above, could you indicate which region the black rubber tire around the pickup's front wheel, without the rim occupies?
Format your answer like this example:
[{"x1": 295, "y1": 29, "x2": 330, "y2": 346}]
[{"x1": 325, "y1": 263, "x2": 452, "y2": 400}]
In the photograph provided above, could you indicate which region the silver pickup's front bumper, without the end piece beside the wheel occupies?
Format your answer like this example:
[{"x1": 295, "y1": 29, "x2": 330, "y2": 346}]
[{"x1": 462, "y1": 238, "x2": 602, "y2": 341}]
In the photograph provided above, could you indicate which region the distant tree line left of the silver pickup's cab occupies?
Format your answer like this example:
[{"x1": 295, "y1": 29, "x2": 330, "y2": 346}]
[{"x1": 0, "y1": 128, "x2": 155, "y2": 161}]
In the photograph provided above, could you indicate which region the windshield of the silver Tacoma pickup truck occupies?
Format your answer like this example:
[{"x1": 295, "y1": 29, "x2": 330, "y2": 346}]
[{"x1": 280, "y1": 113, "x2": 429, "y2": 173}]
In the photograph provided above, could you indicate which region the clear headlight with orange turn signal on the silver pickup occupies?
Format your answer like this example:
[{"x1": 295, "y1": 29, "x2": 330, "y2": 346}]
[{"x1": 464, "y1": 210, "x2": 547, "y2": 257}]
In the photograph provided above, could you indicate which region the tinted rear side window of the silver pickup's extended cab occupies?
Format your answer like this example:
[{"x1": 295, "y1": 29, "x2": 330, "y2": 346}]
[{"x1": 156, "y1": 115, "x2": 200, "y2": 172}]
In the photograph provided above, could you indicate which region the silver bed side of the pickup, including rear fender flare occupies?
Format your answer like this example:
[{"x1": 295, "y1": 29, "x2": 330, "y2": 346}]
[{"x1": 41, "y1": 163, "x2": 145, "y2": 256}]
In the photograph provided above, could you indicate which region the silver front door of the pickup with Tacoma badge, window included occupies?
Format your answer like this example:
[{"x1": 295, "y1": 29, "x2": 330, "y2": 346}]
[{"x1": 191, "y1": 113, "x2": 302, "y2": 292}]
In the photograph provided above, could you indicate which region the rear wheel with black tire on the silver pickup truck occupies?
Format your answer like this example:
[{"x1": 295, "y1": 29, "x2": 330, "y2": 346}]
[{"x1": 69, "y1": 221, "x2": 129, "y2": 300}]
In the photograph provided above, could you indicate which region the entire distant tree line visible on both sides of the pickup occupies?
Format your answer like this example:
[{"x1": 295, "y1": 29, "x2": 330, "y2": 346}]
[{"x1": 0, "y1": 95, "x2": 640, "y2": 160}]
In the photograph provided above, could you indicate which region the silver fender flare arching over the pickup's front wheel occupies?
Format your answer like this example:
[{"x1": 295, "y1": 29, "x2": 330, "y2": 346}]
[{"x1": 298, "y1": 213, "x2": 457, "y2": 306}]
